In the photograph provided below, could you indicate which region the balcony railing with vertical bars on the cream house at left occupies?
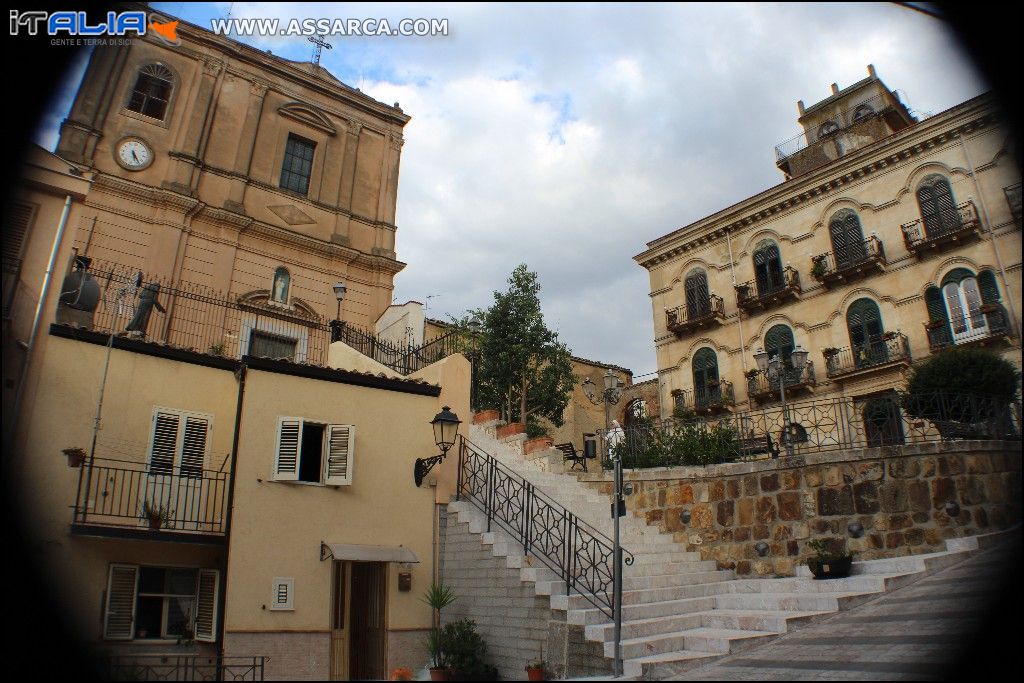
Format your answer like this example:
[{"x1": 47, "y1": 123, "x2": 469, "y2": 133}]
[{"x1": 72, "y1": 458, "x2": 230, "y2": 543}]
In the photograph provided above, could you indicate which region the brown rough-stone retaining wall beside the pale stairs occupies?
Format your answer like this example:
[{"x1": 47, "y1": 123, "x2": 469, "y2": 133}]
[{"x1": 581, "y1": 440, "x2": 1021, "y2": 575}]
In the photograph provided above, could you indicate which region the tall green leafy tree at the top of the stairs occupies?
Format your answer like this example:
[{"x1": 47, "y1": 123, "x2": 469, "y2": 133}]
[{"x1": 464, "y1": 263, "x2": 575, "y2": 426}]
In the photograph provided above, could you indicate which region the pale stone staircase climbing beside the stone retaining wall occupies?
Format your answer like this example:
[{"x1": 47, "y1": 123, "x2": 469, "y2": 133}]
[{"x1": 449, "y1": 423, "x2": 999, "y2": 678}]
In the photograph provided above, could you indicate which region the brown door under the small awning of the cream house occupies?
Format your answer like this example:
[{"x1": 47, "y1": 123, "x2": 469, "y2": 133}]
[{"x1": 349, "y1": 562, "x2": 387, "y2": 681}]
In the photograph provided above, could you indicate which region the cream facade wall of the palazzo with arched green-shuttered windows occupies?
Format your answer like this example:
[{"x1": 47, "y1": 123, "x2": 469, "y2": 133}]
[{"x1": 636, "y1": 97, "x2": 1022, "y2": 417}]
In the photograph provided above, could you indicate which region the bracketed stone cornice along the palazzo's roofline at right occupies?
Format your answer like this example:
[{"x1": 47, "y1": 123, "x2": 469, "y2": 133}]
[{"x1": 633, "y1": 94, "x2": 997, "y2": 270}]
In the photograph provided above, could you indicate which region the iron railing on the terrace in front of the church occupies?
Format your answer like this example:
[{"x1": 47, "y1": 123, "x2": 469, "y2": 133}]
[{"x1": 59, "y1": 261, "x2": 472, "y2": 375}]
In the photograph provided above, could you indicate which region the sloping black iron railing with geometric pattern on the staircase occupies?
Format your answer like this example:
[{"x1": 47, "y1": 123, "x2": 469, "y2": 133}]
[{"x1": 456, "y1": 437, "x2": 634, "y2": 618}]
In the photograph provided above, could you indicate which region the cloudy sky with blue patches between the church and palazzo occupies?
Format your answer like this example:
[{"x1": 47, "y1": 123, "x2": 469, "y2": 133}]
[{"x1": 37, "y1": 3, "x2": 987, "y2": 375}]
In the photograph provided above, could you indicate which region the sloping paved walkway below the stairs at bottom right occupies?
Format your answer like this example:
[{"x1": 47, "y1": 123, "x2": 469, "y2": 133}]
[{"x1": 667, "y1": 539, "x2": 1022, "y2": 681}]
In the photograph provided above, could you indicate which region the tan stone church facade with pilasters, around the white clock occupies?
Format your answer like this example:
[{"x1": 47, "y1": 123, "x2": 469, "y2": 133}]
[{"x1": 58, "y1": 8, "x2": 409, "y2": 329}]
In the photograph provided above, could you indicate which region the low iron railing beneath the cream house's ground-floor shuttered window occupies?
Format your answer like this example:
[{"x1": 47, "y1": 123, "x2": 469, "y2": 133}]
[{"x1": 100, "y1": 654, "x2": 265, "y2": 681}]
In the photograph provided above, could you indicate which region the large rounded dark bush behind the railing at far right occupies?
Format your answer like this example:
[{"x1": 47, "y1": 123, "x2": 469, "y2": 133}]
[{"x1": 906, "y1": 346, "x2": 1020, "y2": 403}]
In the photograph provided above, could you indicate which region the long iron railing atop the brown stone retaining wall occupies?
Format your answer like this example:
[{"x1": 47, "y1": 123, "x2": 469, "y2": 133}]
[{"x1": 601, "y1": 392, "x2": 1021, "y2": 469}]
